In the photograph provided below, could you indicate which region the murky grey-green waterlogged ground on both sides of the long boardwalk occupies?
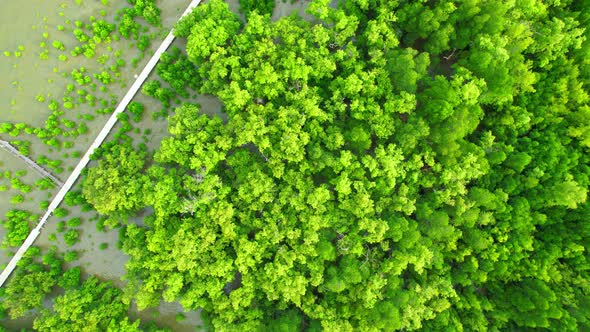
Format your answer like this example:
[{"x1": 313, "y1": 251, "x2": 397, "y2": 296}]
[{"x1": 0, "y1": 0, "x2": 324, "y2": 331}]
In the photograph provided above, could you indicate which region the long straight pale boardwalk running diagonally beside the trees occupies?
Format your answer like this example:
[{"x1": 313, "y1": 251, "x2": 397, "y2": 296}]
[{"x1": 0, "y1": 0, "x2": 201, "y2": 287}]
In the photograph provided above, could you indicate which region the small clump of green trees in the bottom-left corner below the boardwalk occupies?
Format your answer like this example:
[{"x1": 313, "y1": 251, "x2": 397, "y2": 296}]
[{"x1": 0, "y1": 247, "x2": 167, "y2": 332}]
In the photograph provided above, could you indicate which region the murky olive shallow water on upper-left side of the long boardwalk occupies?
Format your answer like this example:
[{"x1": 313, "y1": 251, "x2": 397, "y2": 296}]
[{"x1": 0, "y1": 0, "x2": 190, "y2": 256}]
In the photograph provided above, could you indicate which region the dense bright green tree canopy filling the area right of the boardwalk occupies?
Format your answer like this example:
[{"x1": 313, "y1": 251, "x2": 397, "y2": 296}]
[{"x1": 84, "y1": 0, "x2": 590, "y2": 331}]
